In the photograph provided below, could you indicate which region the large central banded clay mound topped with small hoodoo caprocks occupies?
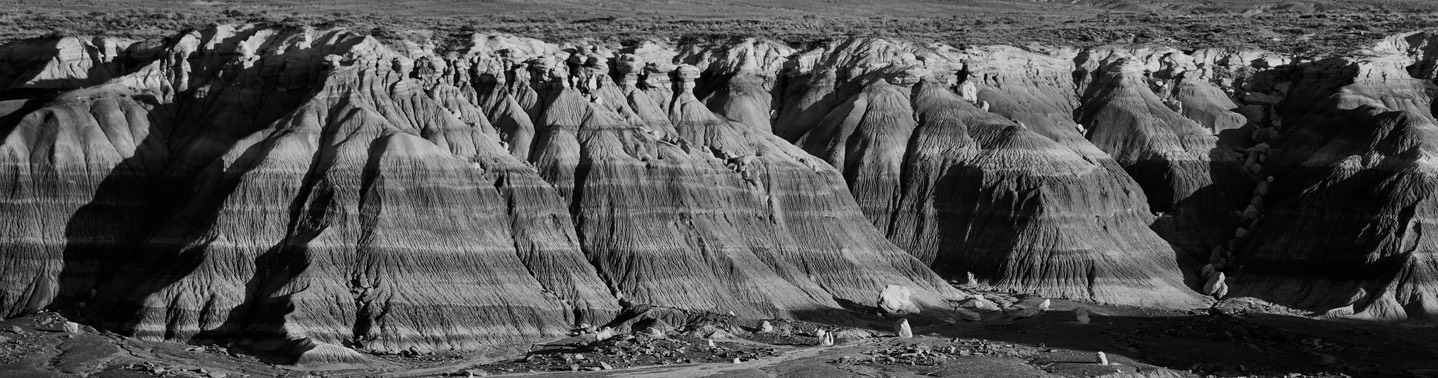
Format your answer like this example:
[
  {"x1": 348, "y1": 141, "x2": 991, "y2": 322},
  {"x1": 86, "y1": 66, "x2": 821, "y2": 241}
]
[{"x1": 416, "y1": 37, "x2": 962, "y2": 318}]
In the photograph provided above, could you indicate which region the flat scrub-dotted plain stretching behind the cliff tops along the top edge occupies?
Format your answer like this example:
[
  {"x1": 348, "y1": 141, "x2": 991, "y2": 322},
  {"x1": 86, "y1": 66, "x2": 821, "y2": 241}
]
[{"x1": 0, "y1": 0, "x2": 1438, "y2": 56}]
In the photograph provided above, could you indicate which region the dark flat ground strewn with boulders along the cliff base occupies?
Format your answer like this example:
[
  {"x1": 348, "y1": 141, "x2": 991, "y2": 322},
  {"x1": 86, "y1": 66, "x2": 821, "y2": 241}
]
[{"x1": 0, "y1": 293, "x2": 1438, "y2": 378}]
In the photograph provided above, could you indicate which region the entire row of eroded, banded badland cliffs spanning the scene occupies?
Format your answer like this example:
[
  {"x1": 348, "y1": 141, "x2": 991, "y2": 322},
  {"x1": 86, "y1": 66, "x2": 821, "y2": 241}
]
[{"x1": 0, "y1": 24, "x2": 1438, "y2": 364}]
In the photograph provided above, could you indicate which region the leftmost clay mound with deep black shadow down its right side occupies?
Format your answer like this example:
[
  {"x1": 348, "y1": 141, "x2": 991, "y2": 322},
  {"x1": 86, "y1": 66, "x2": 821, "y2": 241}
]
[{"x1": 0, "y1": 26, "x2": 365, "y2": 319}]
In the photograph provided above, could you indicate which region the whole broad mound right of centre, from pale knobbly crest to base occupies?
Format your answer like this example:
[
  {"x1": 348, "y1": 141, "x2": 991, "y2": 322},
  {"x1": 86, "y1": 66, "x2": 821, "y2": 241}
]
[{"x1": 781, "y1": 42, "x2": 1205, "y2": 308}]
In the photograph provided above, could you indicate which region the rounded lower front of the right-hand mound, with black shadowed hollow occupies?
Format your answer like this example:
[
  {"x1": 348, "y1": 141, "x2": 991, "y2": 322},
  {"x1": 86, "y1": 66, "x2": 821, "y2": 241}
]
[{"x1": 920, "y1": 82, "x2": 1205, "y2": 308}]
